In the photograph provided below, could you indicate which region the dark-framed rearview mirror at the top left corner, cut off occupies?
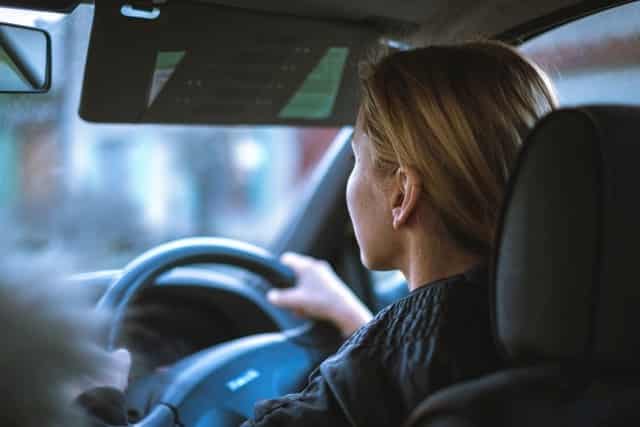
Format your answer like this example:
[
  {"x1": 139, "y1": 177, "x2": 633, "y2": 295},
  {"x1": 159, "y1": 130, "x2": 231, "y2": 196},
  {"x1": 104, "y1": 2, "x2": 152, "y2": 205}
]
[{"x1": 0, "y1": 23, "x2": 51, "y2": 93}]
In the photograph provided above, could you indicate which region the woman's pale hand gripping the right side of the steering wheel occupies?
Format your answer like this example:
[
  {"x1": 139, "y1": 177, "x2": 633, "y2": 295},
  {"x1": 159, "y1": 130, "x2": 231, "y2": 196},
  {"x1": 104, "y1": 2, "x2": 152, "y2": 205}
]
[{"x1": 267, "y1": 253, "x2": 373, "y2": 337}]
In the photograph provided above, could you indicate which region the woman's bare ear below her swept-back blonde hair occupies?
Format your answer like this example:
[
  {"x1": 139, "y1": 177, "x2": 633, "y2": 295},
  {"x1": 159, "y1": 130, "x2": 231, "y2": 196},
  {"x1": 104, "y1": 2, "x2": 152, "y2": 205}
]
[{"x1": 391, "y1": 166, "x2": 422, "y2": 230}]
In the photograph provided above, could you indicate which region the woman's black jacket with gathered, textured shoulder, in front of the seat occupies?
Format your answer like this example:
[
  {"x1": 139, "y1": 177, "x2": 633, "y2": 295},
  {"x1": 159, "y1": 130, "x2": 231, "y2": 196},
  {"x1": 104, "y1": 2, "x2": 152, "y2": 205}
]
[{"x1": 243, "y1": 266, "x2": 499, "y2": 427}]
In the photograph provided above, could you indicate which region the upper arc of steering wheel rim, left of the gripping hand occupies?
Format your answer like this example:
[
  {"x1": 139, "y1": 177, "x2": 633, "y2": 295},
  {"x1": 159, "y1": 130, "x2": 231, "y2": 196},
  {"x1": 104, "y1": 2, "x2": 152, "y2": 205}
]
[{"x1": 96, "y1": 237, "x2": 300, "y2": 350}]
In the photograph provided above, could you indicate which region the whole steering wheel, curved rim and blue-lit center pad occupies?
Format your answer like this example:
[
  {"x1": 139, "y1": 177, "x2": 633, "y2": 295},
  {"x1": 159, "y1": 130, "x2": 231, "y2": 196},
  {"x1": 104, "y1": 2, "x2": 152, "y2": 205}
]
[{"x1": 97, "y1": 237, "x2": 341, "y2": 427}]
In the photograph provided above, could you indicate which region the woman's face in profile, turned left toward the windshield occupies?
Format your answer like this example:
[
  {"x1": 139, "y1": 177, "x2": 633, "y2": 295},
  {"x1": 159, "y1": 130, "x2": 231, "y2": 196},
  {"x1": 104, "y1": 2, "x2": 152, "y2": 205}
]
[{"x1": 347, "y1": 126, "x2": 394, "y2": 270}]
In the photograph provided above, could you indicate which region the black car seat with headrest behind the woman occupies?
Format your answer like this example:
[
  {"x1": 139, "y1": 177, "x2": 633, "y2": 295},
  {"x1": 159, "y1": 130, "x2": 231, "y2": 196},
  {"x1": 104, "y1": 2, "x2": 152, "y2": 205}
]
[{"x1": 408, "y1": 106, "x2": 640, "y2": 427}]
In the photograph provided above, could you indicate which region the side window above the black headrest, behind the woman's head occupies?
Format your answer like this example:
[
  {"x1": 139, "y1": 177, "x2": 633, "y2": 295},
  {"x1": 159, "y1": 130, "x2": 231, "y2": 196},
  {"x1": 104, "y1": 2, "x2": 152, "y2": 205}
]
[{"x1": 520, "y1": 2, "x2": 640, "y2": 106}]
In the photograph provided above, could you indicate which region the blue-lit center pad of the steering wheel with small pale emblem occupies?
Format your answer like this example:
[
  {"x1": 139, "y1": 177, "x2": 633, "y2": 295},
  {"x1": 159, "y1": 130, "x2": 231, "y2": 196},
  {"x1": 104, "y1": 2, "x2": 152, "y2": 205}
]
[{"x1": 161, "y1": 333, "x2": 318, "y2": 425}]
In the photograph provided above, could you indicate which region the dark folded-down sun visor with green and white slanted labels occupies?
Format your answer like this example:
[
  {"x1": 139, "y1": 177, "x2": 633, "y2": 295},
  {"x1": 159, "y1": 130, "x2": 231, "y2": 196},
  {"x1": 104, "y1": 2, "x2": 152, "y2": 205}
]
[{"x1": 80, "y1": 0, "x2": 379, "y2": 126}]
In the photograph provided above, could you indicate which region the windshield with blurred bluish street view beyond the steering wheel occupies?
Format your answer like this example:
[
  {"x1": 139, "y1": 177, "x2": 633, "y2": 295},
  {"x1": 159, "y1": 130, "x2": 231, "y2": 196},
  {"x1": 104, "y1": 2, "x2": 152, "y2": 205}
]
[{"x1": 0, "y1": 5, "x2": 339, "y2": 271}]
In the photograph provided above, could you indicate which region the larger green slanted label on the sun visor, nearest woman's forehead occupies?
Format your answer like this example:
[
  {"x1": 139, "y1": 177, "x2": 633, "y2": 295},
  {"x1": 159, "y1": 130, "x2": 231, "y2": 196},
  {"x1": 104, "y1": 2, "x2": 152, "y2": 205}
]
[{"x1": 278, "y1": 47, "x2": 349, "y2": 120}]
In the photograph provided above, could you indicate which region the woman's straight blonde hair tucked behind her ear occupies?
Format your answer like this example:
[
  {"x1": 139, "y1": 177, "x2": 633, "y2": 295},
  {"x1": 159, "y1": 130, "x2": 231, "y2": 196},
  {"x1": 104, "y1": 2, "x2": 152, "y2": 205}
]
[{"x1": 359, "y1": 41, "x2": 556, "y2": 256}]
